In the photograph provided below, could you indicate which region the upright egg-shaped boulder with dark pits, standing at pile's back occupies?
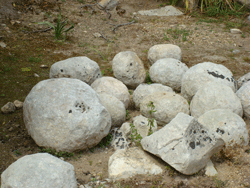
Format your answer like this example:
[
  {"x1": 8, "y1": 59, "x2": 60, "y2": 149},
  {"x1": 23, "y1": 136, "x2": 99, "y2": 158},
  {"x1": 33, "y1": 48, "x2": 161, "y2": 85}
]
[{"x1": 112, "y1": 51, "x2": 146, "y2": 89}]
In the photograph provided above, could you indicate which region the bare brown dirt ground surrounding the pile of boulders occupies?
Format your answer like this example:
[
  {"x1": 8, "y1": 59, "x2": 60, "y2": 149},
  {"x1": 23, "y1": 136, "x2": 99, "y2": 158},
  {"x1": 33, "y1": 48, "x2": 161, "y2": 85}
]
[{"x1": 0, "y1": 0, "x2": 250, "y2": 188}]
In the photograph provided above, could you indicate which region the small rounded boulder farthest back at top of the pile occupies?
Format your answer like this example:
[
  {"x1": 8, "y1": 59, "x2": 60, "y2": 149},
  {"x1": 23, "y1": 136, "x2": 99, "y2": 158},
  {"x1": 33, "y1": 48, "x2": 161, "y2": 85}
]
[{"x1": 148, "y1": 44, "x2": 181, "y2": 65}]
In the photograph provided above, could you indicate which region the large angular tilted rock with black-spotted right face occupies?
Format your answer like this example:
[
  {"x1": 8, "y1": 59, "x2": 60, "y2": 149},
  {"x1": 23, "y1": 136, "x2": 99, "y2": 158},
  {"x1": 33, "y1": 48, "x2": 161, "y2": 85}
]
[{"x1": 141, "y1": 113, "x2": 224, "y2": 175}]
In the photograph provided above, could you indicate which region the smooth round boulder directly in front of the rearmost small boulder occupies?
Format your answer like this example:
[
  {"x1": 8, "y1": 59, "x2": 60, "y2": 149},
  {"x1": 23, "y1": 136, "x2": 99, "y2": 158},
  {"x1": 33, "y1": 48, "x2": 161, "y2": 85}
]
[{"x1": 149, "y1": 58, "x2": 188, "y2": 91}]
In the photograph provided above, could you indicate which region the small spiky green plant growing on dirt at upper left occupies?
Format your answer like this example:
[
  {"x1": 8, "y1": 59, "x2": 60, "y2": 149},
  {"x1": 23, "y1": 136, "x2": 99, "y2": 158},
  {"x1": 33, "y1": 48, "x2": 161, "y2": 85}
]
[{"x1": 38, "y1": 9, "x2": 74, "y2": 40}]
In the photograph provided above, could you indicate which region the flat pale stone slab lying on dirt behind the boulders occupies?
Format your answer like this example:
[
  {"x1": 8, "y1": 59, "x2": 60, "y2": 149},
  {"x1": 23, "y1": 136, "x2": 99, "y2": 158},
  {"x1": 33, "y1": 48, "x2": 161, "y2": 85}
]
[{"x1": 138, "y1": 6, "x2": 183, "y2": 16}]
